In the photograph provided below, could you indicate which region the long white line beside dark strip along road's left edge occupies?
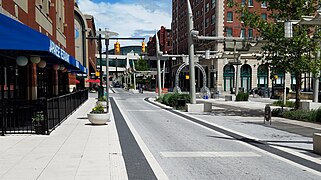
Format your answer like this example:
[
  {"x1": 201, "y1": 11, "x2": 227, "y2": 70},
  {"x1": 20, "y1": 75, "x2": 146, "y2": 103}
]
[{"x1": 115, "y1": 101, "x2": 169, "y2": 180}]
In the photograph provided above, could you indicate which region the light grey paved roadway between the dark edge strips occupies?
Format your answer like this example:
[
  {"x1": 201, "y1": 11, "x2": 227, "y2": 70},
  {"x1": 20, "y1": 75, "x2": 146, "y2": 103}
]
[{"x1": 111, "y1": 89, "x2": 321, "y2": 179}]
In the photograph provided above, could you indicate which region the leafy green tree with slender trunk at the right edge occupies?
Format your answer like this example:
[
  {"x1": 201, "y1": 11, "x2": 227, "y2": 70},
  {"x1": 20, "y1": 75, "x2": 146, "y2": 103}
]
[{"x1": 234, "y1": 0, "x2": 321, "y2": 109}]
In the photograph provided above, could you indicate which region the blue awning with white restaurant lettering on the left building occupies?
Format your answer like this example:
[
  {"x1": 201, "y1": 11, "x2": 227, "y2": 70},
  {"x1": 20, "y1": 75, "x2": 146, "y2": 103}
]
[{"x1": 0, "y1": 13, "x2": 88, "y2": 74}]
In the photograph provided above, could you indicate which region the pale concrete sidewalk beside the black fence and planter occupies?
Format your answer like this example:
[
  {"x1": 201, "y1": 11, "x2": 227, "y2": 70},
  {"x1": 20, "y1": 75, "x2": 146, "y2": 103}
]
[{"x1": 0, "y1": 98, "x2": 128, "y2": 180}]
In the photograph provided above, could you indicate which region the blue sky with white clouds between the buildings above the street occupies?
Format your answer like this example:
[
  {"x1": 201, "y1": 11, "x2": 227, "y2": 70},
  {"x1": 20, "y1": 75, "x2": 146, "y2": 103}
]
[{"x1": 77, "y1": 0, "x2": 172, "y2": 48}]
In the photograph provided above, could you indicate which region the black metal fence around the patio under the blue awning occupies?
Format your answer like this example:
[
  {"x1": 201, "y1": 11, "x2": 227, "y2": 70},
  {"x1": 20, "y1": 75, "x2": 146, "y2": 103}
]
[{"x1": 0, "y1": 90, "x2": 88, "y2": 135}]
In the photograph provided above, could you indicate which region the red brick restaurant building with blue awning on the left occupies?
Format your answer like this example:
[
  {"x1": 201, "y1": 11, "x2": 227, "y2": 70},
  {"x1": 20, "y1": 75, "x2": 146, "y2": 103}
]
[{"x1": 0, "y1": 0, "x2": 88, "y2": 135}]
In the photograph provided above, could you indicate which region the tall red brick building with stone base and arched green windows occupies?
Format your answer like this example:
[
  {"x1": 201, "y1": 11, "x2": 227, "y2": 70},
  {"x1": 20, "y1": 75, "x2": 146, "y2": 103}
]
[{"x1": 172, "y1": 0, "x2": 276, "y2": 93}]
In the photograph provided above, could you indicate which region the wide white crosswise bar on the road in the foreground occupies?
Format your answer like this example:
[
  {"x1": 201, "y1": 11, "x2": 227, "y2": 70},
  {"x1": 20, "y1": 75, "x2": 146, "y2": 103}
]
[{"x1": 160, "y1": 151, "x2": 261, "y2": 158}]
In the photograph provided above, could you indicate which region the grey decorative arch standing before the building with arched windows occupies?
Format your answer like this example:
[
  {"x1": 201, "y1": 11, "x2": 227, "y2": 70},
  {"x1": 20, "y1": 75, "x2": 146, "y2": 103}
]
[{"x1": 174, "y1": 62, "x2": 211, "y2": 98}]
